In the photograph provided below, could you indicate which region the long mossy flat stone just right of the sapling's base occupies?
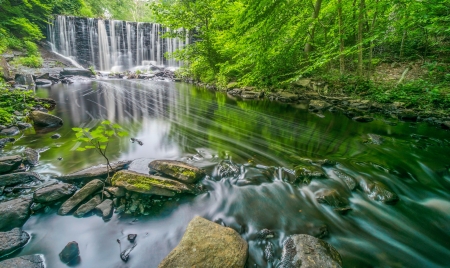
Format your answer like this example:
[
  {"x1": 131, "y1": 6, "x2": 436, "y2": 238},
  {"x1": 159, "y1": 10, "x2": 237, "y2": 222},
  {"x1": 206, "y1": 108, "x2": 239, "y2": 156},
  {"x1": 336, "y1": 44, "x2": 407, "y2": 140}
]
[{"x1": 111, "y1": 170, "x2": 194, "y2": 196}]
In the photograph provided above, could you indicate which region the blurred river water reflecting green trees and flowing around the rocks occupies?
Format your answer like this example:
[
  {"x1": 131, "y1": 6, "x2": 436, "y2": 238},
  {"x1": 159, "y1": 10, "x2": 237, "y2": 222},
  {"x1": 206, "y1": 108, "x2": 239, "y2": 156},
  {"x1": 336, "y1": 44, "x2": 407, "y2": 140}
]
[{"x1": 1, "y1": 80, "x2": 450, "y2": 267}]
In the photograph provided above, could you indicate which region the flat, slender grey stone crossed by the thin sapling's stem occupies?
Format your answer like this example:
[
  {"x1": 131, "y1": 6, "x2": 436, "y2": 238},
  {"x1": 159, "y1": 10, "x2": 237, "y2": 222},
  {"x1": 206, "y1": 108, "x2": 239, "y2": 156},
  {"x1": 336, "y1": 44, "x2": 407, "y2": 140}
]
[{"x1": 57, "y1": 161, "x2": 131, "y2": 181}]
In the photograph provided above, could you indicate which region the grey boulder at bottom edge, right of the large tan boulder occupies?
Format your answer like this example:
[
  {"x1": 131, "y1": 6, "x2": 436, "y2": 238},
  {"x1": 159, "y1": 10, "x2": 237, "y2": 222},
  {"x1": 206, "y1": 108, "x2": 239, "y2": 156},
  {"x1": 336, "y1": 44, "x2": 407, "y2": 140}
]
[{"x1": 281, "y1": 234, "x2": 342, "y2": 268}]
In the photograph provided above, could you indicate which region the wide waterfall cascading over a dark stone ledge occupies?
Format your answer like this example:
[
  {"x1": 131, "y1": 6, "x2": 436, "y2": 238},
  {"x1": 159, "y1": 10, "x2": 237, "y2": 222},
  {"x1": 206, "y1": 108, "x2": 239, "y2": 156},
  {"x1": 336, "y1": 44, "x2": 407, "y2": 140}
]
[{"x1": 47, "y1": 16, "x2": 189, "y2": 71}]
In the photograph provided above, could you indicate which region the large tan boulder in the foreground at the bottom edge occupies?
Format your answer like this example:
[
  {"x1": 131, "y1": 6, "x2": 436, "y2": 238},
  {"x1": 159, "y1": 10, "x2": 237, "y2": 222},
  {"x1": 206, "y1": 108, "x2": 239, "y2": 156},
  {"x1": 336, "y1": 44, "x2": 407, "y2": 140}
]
[{"x1": 158, "y1": 216, "x2": 248, "y2": 268}]
